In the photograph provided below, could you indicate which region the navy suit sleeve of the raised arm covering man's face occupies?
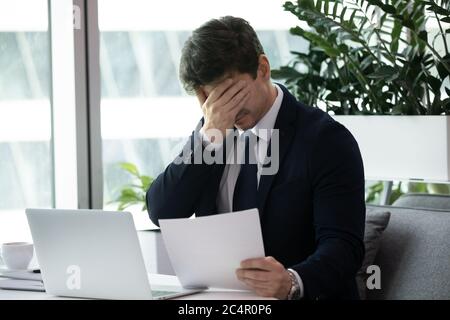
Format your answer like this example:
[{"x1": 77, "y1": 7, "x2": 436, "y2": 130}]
[{"x1": 146, "y1": 122, "x2": 218, "y2": 226}]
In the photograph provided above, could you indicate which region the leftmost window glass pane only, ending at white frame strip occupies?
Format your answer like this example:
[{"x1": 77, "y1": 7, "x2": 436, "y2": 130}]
[{"x1": 0, "y1": 0, "x2": 53, "y2": 242}]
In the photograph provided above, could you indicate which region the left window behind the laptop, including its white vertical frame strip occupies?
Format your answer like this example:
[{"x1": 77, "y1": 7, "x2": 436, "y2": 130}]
[{"x1": 0, "y1": 0, "x2": 79, "y2": 242}]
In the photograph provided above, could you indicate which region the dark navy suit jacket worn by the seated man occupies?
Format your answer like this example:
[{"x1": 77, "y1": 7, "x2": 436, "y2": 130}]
[{"x1": 147, "y1": 86, "x2": 365, "y2": 300}]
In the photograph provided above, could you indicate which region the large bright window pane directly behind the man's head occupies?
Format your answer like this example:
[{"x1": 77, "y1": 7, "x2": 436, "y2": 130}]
[{"x1": 98, "y1": 0, "x2": 307, "y2": 228}]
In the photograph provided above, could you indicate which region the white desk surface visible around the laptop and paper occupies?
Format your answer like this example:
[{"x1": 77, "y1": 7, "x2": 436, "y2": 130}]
[{"x1": 0, "y1": 274, "x2": 273, "y2": 300}]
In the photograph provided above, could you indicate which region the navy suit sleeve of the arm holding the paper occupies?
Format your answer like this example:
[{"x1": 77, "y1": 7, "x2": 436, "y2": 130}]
[{"x1": 292, "y1": 121, "x2": 365, "y2": 300}]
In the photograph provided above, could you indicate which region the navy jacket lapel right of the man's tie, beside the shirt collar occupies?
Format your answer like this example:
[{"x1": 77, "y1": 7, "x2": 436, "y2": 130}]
[{"x1": 258, "y1": 85, "x2": 297, "y2": 217}]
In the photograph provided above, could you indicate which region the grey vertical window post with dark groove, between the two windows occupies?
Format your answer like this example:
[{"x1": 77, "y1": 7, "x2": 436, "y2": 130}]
[{"x1": 71, "y1": 0, "x2": 103, "y2": 209}]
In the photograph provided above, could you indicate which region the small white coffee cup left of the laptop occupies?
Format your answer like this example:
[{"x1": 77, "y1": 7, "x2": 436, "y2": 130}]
[{"x1": 0, "y1": 242, "x2": 33, "y2": 270}]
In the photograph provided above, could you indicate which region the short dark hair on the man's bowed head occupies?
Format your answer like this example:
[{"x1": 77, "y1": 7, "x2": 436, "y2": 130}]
[{"x1": 180, "y1": 16, "x2": 264, "y2": 94}]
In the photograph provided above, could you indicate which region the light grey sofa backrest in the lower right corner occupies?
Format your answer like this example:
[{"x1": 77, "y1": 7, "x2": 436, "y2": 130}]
[{"x1": 368, "y1": 206, "x2": 450, "y2": 299}]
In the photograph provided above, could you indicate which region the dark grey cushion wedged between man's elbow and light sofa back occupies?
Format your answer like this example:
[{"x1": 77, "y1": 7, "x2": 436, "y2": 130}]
[{"x1": 356, "y1": 208, "x2": 391, "y2": 300}]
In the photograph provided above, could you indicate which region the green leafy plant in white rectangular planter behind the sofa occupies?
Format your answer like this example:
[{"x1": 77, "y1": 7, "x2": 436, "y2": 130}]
[{"x1": 272, "y1": 0, "x2": 450, "y2": 181}]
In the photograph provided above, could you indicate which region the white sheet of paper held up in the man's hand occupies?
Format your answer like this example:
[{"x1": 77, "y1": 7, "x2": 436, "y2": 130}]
[{"x1": 159, "y1": 209, "x2": 264, "y2": 290}]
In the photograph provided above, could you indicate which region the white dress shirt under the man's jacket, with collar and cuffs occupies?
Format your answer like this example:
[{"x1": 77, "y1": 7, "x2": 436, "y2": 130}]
[{"x1": 200, "y1": 84, "x2": 303, "y2": 296}]
